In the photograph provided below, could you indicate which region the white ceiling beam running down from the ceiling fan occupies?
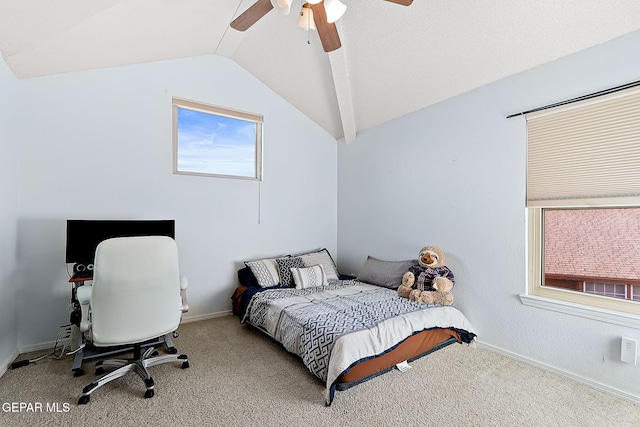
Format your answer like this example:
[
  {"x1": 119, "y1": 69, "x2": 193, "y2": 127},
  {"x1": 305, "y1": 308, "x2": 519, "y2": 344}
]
[{"x1": 327, "y1": 24, "x2": 356, "y2": 144}]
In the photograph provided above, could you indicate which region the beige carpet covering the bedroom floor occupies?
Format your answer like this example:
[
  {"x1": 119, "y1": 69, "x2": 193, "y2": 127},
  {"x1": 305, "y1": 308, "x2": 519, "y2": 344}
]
[{"x1": 0, "y1": 316, "x2": 640, "y2": 427}]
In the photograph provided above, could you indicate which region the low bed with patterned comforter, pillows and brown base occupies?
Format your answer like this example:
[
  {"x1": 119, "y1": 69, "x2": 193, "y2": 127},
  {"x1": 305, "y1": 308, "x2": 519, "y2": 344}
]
[{"x1": 232, "y1": 249, "x2": 475, "y2": 406}]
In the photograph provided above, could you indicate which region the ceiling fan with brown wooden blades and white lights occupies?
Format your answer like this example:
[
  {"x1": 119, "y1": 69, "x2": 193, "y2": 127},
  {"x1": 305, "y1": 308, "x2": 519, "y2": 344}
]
[{"x1": 231, "y1": 0, "x2": 413, "y2": 52}]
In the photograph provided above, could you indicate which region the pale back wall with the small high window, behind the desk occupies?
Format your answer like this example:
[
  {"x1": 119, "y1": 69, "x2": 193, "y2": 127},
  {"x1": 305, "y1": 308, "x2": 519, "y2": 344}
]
[{"x1": 12, "y1": 56, "x2": 337, "y2": 348}]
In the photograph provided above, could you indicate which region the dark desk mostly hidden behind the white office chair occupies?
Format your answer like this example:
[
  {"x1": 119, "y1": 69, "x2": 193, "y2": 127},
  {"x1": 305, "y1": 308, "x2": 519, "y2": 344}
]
[{"x1": 69, "y1": 276, "x2": 178, "y2": 377}]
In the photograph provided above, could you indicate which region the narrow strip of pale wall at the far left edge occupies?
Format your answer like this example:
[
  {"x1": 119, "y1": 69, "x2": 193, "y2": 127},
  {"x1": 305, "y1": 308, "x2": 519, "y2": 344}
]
[{"x1": 0, "y1": 59, "x2": 20, "y2": 375}]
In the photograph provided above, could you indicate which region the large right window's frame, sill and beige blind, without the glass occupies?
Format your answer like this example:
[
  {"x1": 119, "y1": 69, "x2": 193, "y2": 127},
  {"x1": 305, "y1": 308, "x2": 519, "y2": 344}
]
[{"x1": 524, "y1": 82, "x2": 640, "y2": 329}]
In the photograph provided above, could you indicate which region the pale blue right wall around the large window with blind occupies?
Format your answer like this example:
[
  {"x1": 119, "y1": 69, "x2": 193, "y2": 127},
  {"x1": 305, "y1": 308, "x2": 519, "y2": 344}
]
[{"x1": 338, "y1": 32, "x2": 640, "y2": 401}]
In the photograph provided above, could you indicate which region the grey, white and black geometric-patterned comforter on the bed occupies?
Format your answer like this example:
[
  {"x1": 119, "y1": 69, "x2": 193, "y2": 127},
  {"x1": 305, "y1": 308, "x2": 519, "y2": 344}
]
[{"x1": 242, "y1": 280, "x2": 475, "y2": 405}]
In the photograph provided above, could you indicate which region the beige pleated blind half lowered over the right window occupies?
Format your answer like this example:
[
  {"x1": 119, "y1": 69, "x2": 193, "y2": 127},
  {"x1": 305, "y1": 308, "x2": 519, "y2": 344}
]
[{"x1": 527, "y1": 87, "x2": 640, "y2": 207}]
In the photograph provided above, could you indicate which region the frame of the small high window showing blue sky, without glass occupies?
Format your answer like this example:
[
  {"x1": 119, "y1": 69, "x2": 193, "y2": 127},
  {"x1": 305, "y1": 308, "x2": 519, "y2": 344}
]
[{"x1": 172, "y1": 97, "x2": 263, "y2": 181}]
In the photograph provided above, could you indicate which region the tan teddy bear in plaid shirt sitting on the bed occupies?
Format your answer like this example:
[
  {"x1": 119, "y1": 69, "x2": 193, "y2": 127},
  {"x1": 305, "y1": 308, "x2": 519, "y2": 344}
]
[{"x1": 398, "y1": 246, "x2": 455, "y2": 305}]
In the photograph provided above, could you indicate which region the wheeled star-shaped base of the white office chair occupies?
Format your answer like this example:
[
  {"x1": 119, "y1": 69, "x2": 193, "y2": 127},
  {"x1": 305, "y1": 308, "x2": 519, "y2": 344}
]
[{"x1": 78, "y1": 344, "x2": 189, "y2": 405}]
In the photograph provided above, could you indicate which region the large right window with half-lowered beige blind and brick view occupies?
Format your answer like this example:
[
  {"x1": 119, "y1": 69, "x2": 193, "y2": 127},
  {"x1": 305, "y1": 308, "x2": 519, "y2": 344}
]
[{"x1": 526, "y1": 87, "x2": 640, "y2": 315}]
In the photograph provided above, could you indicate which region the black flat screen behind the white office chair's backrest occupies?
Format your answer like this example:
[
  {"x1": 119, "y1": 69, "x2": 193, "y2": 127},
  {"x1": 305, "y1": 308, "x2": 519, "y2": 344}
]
[{"x1": 66, "y1": 219, "x2": 175, "y2": 265}]
